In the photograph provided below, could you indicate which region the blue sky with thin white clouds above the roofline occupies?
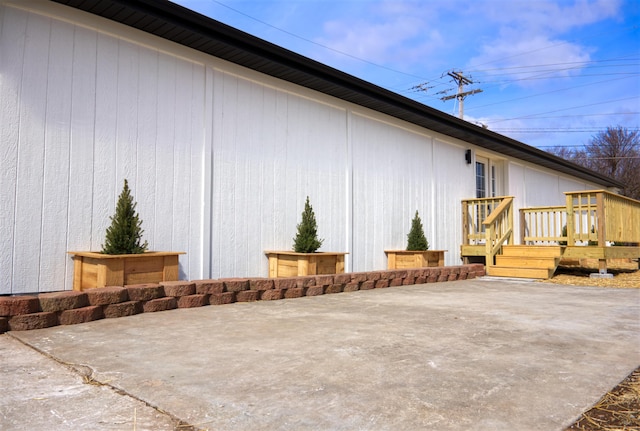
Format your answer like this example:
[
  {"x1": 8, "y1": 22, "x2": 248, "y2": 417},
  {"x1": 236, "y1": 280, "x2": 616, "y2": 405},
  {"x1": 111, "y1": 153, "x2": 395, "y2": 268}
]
[{"x1": 170, "y1": 0, "x2": 640, "y2": 149}]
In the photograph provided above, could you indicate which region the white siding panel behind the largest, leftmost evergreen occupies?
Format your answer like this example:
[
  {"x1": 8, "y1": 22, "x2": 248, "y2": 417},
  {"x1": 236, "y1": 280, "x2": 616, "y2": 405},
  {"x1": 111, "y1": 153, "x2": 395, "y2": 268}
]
[{"x1": 0, "y1": 5, "x2": 205, "y2": 293}]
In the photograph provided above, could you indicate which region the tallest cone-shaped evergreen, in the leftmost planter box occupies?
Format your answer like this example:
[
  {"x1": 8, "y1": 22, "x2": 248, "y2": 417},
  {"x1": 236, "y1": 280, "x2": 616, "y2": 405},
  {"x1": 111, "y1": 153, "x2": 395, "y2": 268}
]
[{"x1": 102, "y1": 179, "x2": 149, "y2": 254}]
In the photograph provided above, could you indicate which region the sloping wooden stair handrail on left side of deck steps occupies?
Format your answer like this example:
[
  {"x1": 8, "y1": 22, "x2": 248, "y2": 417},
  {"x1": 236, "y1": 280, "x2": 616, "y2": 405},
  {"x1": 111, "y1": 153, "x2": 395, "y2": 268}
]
[{"x1": 482, "y1": 196, "x2": 513, "y2": 268}]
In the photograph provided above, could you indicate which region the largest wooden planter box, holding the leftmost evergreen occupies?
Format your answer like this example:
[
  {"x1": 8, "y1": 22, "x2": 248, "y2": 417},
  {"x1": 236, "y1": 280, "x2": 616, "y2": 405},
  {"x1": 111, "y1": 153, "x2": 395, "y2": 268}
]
[{"x1": 69, "y1": 251, "x2": 184, "y2": 291}]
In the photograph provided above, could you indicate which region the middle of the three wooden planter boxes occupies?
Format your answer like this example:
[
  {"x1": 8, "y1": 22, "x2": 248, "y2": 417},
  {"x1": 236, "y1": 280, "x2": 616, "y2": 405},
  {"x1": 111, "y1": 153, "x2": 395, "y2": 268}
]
[{"x1": 265, "y1": 251, "x2": 347, "y2": 278}]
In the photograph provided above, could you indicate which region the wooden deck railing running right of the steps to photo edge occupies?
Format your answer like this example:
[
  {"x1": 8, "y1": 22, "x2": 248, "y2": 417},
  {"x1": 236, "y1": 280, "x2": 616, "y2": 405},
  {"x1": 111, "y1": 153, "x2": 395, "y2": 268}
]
[{"x1": 520, "y1": 190, "x2": 640, "y2": 246}]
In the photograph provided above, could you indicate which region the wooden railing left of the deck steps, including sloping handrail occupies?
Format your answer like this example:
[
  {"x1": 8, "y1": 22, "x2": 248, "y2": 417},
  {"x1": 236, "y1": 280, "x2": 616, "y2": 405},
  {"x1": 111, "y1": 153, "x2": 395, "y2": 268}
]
[{"x1": 462, "y1": 196, "x2": 513, "y2": 267}]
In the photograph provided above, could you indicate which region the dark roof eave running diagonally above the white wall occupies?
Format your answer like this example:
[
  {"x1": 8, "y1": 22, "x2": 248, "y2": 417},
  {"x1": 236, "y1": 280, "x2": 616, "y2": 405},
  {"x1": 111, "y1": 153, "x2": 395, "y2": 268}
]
[{"x1": 52, "y1": 0, "x2": 623, "y2": 188}]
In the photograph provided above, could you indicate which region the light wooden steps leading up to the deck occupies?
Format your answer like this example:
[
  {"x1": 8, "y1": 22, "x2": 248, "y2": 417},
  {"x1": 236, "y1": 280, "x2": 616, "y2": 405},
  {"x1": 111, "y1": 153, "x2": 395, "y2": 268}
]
[{"x1": 487, "y1": 245, "x2": 562, "y2": 279}]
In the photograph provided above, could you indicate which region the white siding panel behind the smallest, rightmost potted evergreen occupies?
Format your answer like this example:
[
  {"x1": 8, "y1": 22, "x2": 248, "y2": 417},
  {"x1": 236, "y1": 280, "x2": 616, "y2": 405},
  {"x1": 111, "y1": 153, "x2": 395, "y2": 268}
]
[{"x1": 351, "y1": 114, "x2": 433, "y2": 271}]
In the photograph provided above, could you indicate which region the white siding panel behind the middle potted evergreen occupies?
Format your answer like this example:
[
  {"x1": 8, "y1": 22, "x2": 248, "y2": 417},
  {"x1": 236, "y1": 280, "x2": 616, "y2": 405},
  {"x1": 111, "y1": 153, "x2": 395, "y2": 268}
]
[{"x1": 211, "y1": 70, "x2": 348, "y2": 277}]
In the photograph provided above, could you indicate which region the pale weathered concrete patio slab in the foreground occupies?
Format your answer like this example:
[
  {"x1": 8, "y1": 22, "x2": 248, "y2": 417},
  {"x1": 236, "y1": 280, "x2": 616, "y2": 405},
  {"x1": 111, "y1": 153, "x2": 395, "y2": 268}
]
[{"x1": 0, "y1": 278, "x2": 640, "y2": 430}]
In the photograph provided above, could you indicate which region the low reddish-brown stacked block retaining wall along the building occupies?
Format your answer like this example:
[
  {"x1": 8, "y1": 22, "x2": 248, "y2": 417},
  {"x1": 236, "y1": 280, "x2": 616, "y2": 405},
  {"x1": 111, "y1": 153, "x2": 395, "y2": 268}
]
[{"x1": 0, "y1": 264, "x2": 484, "y2": 334}]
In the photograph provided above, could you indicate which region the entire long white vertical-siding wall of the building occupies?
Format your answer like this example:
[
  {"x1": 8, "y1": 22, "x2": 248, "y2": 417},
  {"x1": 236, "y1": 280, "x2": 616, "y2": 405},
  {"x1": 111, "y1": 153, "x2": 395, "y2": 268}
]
[{"x1": 0, "y1": 0, "x2": 608, "y2": 294}]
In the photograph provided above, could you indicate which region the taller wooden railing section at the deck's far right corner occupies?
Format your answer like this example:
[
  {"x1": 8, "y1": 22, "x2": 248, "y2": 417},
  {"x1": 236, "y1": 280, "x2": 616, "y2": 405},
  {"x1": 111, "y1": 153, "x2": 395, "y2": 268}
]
[{"x1": 565, "y1": 190, "x2": 640, "y2": 247}]
